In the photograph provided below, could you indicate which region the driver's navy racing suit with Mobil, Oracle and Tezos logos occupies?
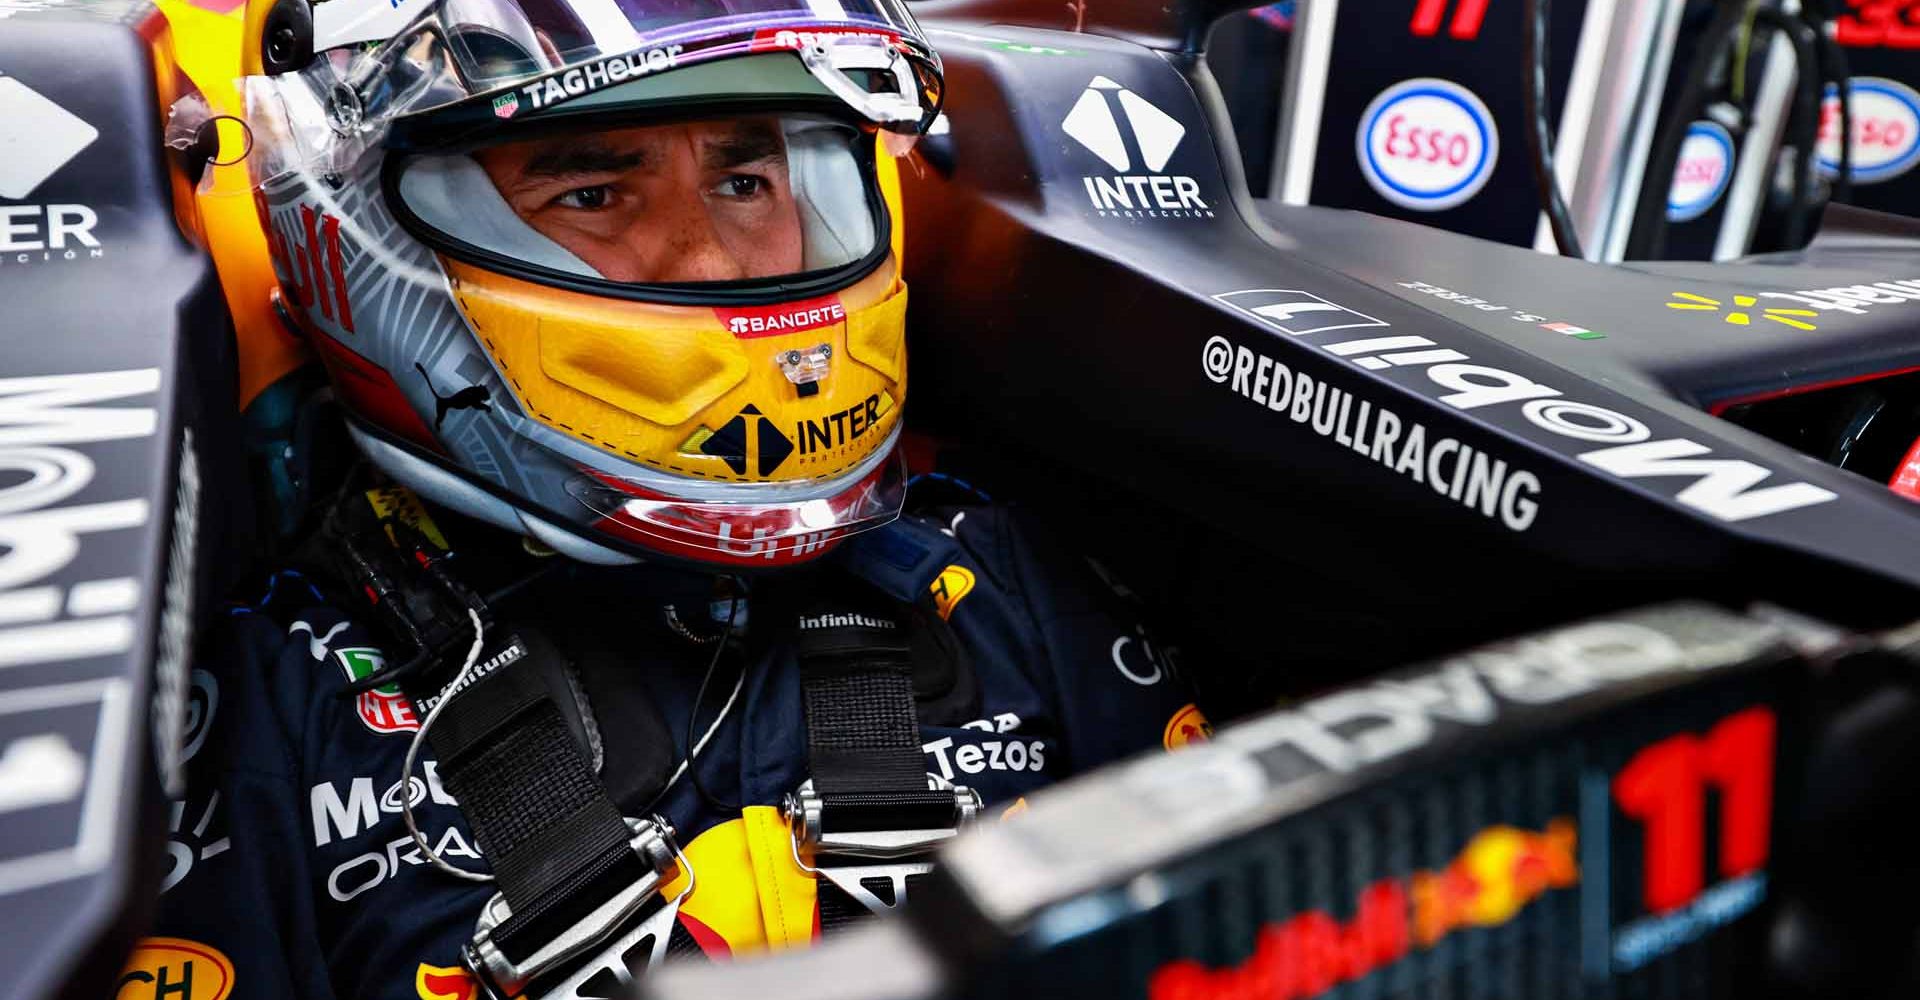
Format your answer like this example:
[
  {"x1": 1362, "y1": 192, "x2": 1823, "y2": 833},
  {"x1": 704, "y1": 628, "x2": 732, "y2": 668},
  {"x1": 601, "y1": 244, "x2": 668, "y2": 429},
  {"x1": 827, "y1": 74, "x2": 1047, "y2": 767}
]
[{"x1": 142, "y1": 507, "x2": 1206, "y2": 1000}]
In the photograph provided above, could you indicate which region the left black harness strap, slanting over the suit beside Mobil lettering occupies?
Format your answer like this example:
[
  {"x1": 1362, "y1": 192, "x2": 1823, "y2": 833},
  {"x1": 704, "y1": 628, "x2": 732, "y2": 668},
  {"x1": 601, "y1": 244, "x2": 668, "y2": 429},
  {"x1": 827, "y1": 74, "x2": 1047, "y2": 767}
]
[{"x1": 426, "y1": 645, "x2": 651, "y2": 962}]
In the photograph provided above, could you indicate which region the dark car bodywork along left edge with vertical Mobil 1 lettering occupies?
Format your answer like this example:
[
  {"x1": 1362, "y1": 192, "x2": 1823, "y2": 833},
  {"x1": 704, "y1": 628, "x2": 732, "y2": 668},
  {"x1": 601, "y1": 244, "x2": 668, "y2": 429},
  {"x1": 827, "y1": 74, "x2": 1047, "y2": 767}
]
[{"x1": 0, "y1": 13, "x2": 252, "y2": 996}]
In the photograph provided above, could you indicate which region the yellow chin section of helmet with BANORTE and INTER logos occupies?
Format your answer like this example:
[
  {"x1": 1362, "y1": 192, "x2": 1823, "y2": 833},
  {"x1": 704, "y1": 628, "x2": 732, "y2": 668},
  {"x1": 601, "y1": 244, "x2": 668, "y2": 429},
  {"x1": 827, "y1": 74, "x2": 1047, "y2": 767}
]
[{"x1": 442, "y1": 259, "x2": 906, "y2": 482}]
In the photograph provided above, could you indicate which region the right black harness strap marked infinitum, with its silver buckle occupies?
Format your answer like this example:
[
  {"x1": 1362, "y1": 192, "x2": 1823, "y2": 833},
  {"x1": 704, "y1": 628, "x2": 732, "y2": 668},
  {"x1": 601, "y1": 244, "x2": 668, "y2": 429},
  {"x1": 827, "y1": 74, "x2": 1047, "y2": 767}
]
[{"x1": 785, "y1": 591, "x2": 979, "y2": 931}]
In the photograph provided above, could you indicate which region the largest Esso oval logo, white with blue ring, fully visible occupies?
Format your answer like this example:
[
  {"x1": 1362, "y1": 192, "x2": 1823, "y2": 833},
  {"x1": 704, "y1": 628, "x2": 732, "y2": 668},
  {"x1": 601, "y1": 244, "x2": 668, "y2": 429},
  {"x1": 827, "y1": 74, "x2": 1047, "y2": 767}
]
[{"x1": 1356, "y1": 77, "x2": 1500, "y2": 211}]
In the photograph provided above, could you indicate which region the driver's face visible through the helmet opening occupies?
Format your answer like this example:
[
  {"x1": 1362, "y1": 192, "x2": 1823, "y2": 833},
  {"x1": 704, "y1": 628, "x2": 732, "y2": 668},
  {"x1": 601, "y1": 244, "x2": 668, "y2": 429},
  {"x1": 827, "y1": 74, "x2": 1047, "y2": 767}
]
[{"x1": 487, "y1": 117, "x2": 801, "y2": 282}]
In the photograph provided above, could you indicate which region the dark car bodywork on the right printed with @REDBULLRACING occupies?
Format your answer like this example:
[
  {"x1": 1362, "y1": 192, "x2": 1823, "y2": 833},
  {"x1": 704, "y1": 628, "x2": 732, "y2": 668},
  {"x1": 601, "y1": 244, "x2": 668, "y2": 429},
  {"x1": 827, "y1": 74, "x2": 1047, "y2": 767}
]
[{"x1": 906, "y1": 19, "x2": 1920, "y2": 676}]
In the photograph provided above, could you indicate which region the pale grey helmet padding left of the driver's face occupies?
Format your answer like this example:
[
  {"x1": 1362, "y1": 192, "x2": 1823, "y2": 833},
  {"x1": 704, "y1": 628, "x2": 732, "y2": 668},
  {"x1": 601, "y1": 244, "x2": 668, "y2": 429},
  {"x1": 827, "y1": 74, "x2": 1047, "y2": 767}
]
[{"x1": 399, "y1": 154, "x2": 603, "y2": 278}]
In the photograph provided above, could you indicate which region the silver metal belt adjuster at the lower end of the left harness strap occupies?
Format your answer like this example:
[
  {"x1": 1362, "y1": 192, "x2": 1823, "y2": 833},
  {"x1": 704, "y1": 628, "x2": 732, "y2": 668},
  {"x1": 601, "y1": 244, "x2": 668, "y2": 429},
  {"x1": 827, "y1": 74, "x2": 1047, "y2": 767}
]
[{"x1": 461, "y1": 816, "x2": 693, "y2": 1000}]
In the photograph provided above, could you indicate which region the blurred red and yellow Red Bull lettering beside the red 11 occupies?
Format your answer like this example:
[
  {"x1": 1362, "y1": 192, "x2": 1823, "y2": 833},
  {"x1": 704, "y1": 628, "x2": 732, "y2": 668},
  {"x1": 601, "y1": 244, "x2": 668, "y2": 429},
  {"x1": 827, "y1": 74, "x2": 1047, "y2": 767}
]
[{"x1": 1148, "y1": 818, "x2": 1580, "y2": 1000}]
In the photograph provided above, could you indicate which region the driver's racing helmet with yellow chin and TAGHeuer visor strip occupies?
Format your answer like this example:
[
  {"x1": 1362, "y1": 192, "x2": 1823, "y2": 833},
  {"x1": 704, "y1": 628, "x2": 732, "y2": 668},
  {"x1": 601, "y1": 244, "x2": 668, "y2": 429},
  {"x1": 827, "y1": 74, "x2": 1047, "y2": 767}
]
[{"x1": 244, "y1": 0, "x2": 941, "y2": 568}]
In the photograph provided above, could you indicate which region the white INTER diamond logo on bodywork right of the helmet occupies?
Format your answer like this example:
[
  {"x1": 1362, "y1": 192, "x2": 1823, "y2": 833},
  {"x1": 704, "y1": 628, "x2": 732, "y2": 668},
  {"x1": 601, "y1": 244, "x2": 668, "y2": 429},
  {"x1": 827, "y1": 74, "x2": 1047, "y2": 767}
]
[{"x1": 1060, "y1": 77, "x2": 1213, "y2": 219}]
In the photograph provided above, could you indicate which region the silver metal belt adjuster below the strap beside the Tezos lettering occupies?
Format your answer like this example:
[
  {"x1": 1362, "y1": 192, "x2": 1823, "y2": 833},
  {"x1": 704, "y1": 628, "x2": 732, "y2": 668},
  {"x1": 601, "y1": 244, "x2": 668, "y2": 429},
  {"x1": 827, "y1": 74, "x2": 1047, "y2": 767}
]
[{"x1": 781, "y1": 779, "x2": 981, "y2": 914}]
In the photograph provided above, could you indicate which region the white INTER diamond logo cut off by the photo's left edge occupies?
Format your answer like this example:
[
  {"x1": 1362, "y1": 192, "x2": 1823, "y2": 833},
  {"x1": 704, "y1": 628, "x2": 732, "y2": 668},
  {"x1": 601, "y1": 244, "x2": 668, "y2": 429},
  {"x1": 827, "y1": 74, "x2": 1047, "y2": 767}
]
[{"x1": 0, "y1": 77, "x2": 106, "y2": 265}]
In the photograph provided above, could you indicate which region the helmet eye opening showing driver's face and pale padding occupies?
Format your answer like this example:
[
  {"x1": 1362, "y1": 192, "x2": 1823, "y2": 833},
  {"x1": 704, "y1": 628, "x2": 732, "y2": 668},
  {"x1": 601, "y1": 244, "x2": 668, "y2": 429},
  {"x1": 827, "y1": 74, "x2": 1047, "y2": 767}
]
[{"x1": 390, "y1": 115, "x2": 885, "y2": 288}]
